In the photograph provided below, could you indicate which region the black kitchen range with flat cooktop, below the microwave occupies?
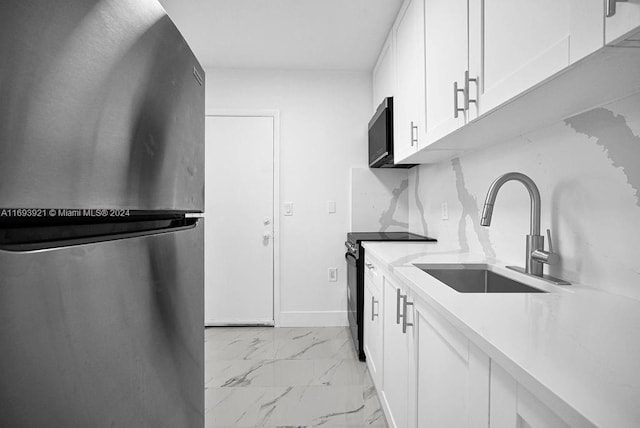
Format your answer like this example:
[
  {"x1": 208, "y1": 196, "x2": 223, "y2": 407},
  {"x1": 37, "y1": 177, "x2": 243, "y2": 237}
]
[{"x1": 344, "y1": 232, "x2": 435, "y2": 361}]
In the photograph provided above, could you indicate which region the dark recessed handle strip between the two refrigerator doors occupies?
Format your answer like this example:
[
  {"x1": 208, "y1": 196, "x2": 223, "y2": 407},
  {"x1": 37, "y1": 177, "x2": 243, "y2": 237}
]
[{"x1": 0, "y1": 217, "x2": 199, "y2": 252}]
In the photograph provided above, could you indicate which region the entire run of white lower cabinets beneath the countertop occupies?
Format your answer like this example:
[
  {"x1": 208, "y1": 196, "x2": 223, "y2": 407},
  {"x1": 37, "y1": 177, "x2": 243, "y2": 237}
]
[{"x1": 364, "y1": 258, "x2": 594, "y2": 428}]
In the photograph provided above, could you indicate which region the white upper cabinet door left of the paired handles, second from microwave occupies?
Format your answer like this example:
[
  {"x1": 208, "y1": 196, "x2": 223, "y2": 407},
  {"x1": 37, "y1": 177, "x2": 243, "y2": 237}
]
[{"x1": 425, "y1": 0, "x2": 475, "y2": 144}]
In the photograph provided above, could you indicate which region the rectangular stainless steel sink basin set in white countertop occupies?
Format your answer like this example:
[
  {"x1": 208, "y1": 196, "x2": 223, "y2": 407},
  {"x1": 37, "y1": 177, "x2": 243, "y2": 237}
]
[{"x1": 414, "y1": 264, "x2": 546, "y2": 293}]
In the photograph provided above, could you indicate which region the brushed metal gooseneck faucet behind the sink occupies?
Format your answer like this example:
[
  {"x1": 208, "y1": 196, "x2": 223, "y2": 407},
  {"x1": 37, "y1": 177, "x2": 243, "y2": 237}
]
[{"x1": 480, "y1": 172, "x2": 568, "y2": 284}]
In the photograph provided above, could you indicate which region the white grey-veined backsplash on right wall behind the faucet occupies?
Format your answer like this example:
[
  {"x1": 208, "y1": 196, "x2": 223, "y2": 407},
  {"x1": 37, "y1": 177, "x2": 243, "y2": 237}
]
[{"x1": 408, "y1": 89, "x2": 640, "y2": 299}]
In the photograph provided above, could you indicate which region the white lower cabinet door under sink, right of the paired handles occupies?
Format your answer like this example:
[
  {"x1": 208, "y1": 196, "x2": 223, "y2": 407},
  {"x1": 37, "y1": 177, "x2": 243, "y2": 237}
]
[{"x1": 415, "y1": 305, "x2": 490, "y2": 428}]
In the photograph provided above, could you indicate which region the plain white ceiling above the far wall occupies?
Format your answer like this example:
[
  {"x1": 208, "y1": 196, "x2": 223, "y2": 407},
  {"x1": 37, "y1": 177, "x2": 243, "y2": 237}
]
[{"x1": 160, "y1": 0, "x2": 402, "y2": 71}]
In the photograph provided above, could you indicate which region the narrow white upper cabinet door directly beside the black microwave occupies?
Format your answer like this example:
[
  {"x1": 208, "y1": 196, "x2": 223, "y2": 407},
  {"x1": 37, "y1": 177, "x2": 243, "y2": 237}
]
[{"x1": 393, "y1": 0, "x2": 425, "y2": 163}]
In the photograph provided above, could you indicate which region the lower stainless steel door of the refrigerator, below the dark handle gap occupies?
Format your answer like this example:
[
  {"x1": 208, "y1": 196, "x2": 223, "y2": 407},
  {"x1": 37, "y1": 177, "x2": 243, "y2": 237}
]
[{"x1": 0, "y1": 220, "x2": 204, "y2": 428}]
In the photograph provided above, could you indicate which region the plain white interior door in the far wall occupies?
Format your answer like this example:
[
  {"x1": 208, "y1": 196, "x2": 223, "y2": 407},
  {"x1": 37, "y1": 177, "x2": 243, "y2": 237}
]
[{"x1": 204, "y1": 116, "x2": 274, "y2": 325}]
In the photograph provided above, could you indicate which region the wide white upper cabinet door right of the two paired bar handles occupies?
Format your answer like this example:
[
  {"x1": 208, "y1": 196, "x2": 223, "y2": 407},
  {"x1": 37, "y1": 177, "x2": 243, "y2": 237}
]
[{"x1": 478, "y1": 0, "x2": 603, "y2": 113}]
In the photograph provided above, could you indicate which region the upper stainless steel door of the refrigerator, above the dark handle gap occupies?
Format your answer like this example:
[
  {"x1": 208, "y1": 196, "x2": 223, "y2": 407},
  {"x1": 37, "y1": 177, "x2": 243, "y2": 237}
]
[{"x1": 0, "y1": 0, "x2": 204, "y2": 211}]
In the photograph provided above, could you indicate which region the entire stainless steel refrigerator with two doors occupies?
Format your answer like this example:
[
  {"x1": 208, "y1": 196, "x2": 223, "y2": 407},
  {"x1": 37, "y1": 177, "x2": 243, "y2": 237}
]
[{"x1": 0, "y1": 0, "x2": 204, "y2": 428}]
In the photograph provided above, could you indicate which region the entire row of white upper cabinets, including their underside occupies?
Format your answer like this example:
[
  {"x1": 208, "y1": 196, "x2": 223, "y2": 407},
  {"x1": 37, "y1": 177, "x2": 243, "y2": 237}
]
[{"x1": 373, "y1": 0, "x2": 640, "y2": 164}]
